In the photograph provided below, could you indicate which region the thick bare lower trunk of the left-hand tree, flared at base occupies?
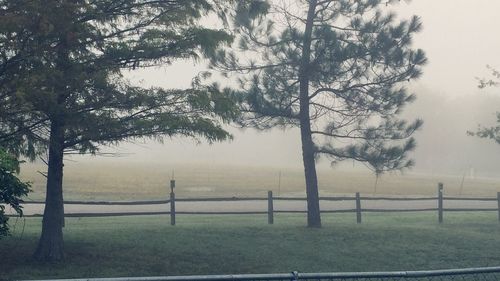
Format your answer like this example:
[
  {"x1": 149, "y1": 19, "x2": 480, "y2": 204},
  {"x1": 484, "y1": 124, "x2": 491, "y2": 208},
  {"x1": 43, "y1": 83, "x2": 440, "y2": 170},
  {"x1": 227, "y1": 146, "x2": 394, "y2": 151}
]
[{"x1": 34, "y1": 121, "x2": 64, "y2": 261}]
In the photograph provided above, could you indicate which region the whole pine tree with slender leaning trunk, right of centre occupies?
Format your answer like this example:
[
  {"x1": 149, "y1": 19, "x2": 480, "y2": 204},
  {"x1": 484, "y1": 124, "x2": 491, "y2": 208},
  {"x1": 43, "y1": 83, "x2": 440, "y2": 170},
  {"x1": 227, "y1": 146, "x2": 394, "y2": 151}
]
[{"x1": 212, "y1": 0, "x2": 426, "y2": 227}]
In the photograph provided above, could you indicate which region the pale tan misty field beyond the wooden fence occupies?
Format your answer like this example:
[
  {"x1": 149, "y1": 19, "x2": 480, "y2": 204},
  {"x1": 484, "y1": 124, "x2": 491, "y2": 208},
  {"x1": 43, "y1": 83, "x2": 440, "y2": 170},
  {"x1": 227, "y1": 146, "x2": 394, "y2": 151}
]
[{"x1": 18, "y1": 161, "x2": 500, "y2": 200}]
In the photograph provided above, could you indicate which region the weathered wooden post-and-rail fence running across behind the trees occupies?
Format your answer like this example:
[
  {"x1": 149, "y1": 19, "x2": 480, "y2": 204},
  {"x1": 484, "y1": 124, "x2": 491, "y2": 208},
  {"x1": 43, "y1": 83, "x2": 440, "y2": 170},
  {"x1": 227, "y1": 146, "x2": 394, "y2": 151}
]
[{"x1": 17, "y1": 181, "x2": 500, "y2": 225}]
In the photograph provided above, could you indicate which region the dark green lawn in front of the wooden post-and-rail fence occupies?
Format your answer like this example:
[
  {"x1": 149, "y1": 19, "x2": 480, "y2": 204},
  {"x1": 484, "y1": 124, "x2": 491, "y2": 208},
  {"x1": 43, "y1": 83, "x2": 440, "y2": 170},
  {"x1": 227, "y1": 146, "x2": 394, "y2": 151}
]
[{"x1": 0, "y1": 213, "x2": 500, "y2": 280}]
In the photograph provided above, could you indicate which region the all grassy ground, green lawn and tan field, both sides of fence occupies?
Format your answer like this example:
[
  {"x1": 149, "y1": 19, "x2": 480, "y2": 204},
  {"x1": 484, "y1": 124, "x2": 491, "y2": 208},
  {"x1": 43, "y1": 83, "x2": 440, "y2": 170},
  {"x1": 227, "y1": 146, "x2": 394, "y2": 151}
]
[{"x1": 9, "y1": 161, "x2": 500, "y2": 280}]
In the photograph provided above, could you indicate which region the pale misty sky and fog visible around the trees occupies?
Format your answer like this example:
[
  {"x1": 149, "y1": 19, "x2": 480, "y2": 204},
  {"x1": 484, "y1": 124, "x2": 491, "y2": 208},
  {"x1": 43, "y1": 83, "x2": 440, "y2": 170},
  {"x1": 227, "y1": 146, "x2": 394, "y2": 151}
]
[{"x1": 72, "y1": 0, "x2": 500, "y2": 176}]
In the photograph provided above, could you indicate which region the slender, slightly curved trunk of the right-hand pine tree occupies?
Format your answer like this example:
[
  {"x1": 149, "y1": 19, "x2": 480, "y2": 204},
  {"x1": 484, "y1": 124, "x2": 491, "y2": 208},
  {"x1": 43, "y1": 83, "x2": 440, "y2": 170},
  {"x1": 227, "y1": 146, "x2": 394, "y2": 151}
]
[{"x1": 299, "y1": 0, "x2": 321, "y2": 227}]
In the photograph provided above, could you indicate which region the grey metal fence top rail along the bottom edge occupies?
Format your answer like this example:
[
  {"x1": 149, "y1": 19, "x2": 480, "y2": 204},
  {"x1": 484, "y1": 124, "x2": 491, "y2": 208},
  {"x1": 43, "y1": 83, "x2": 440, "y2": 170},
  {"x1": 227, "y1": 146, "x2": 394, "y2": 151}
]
[{"x1": 19, "y1": 267, "x2": 500, "y2": 281}]
